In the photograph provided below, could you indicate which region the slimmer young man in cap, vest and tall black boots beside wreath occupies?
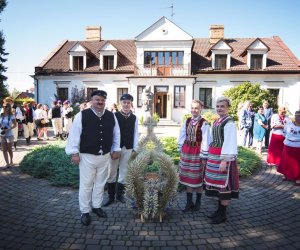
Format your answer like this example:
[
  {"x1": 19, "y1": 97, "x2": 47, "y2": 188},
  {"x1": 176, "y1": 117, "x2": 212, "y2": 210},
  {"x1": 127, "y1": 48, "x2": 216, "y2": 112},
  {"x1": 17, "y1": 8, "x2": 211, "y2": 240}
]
[{"x1": 104, "y1": 94, "x2": 138, "y2": 206}]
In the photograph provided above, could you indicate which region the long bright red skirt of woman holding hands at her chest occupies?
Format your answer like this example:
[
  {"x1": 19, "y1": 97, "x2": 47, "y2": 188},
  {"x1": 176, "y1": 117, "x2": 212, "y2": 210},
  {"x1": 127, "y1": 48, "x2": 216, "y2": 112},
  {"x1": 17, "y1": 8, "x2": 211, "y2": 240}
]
[{"x1": 267, "y1": 134, "x2": 284, "y2": 166}]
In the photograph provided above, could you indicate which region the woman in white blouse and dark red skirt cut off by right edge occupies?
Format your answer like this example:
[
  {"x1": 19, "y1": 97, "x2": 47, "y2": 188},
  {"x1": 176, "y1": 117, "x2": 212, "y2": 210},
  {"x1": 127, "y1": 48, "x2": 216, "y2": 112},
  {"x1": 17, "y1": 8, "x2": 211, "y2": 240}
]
[{"x1": 277, "y1": 110, "x2": 300, "y2": 185}]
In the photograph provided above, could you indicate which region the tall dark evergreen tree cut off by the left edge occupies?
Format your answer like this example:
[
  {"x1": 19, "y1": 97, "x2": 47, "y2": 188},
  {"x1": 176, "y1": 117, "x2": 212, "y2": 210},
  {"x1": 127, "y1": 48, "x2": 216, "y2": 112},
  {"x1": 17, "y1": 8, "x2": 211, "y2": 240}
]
[{"x1": 0, "y1": 0, "x2": 9, "y2": 103}]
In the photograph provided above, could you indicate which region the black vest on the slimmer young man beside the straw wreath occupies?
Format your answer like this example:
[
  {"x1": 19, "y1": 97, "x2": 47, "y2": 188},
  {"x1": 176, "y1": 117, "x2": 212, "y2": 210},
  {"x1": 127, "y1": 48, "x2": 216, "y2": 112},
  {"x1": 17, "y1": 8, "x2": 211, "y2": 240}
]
[{"x1": 115, "y1": 112, "x2": 136, "y2": 149}]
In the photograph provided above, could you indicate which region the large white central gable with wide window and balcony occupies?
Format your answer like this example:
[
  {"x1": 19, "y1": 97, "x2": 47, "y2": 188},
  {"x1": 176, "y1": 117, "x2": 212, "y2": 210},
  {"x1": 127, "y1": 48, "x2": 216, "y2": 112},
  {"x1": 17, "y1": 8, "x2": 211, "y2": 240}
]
[{"x1": 135, "y1": 17, "x2": 193, "y2": 76}]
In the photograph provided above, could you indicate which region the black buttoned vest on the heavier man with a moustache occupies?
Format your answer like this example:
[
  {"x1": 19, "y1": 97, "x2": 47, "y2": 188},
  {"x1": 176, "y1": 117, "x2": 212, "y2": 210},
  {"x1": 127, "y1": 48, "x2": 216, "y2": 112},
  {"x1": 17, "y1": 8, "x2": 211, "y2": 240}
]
[{"x1": 80, "y1": 109, "x2": 115, "y2": 155}]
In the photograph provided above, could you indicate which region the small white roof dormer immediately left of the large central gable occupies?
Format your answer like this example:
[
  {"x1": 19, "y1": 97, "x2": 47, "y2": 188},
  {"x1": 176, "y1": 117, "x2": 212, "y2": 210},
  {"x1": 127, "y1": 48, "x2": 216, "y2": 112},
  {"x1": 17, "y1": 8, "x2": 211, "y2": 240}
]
[{"x1": 99, "y1": 42, "x2": 118, "y2": 70}]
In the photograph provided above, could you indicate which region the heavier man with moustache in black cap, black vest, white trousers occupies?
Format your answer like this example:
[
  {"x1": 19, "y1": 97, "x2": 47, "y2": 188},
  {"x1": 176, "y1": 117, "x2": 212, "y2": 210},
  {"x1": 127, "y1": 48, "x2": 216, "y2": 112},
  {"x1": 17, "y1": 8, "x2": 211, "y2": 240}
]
[{"x1": 66, "y1": 90, "x2": 121, "y2": 226}]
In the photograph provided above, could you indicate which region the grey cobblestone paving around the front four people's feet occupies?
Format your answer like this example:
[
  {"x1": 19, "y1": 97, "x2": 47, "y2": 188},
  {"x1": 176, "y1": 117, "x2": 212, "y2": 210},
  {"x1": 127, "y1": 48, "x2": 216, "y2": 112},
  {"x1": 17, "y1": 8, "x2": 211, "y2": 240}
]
[{"x1": 0, "y1": 130, "x2": 300, "y2": 250}]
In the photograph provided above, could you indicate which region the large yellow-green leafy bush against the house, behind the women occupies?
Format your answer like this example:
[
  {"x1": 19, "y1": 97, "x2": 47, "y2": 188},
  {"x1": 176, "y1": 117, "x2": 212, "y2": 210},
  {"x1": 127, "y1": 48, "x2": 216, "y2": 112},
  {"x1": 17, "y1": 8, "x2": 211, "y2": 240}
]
[{"x1": 224, "y1": 81, "x2": 277, "y2": 120}]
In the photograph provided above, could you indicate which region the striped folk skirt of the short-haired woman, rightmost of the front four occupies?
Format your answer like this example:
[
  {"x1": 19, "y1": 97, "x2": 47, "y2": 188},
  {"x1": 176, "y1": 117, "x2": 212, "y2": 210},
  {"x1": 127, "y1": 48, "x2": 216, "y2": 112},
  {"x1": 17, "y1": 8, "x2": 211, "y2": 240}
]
[{"x1": 204, "y1": 147, "x2": 239, "y2": 200}]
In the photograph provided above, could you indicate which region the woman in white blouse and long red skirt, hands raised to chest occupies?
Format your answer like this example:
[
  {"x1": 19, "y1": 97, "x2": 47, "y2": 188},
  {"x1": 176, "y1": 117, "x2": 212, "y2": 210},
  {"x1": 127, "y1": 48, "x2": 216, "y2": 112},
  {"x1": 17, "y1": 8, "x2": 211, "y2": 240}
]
[{"x1": 267, "y1": 107, "x2": 290, "y2": 166}]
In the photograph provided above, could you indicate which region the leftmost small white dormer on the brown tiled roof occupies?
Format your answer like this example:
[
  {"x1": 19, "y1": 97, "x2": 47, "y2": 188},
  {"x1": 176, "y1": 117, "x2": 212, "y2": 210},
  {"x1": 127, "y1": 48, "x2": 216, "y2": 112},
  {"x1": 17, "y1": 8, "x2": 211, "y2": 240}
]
[{"x1": 68, "y1": 42, "x2": 87, "y2": 71}]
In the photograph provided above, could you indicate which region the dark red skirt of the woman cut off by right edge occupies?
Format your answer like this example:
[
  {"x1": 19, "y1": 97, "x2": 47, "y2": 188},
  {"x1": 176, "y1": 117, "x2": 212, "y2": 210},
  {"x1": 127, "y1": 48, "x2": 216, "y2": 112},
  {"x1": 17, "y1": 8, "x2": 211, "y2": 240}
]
[{"x1": 277, "y1": 145, "x2": 300, "y2": 180}]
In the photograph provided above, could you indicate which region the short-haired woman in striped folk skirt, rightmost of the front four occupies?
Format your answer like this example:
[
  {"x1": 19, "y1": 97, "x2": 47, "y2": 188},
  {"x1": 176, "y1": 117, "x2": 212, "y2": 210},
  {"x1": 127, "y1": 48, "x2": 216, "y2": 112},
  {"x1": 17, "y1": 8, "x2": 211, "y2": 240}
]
[{"x1": 204, "y1": 97, "x2": 239, "y2": 224}]
